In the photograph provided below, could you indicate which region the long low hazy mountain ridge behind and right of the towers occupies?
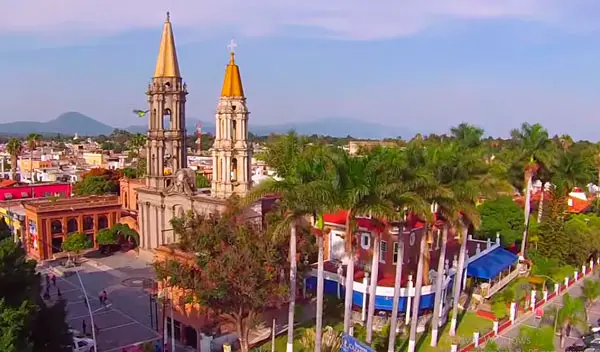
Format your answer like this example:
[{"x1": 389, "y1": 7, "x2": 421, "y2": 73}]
[{"x1": 125, "y1": 117, "x2": 414, "y2": 139}]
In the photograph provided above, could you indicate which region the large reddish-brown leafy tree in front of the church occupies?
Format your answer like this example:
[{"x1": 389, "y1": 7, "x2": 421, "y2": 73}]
[{"x1": 154, "y1": 200, "x2": 296, "y2": 352}]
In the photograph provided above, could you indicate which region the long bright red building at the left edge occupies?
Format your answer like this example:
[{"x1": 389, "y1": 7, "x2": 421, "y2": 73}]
[{"x1": 0, "y1": 180, "x2": 73, "y2": 201}]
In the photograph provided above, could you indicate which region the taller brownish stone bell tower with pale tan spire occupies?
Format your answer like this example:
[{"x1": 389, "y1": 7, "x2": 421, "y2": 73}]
[{"x1": 146, "y1": 12, "x2": 188, "y2": 189}]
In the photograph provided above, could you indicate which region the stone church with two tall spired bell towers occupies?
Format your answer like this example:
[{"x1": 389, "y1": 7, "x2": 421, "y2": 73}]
[{"x1": 137, "y1": 13, "x2": 262, "y2": 251}]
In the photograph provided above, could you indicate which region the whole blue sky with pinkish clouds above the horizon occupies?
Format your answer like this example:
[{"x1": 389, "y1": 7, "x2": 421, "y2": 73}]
[{"x1": 0, "y1": 0, "x2": 600, "y2": 140}]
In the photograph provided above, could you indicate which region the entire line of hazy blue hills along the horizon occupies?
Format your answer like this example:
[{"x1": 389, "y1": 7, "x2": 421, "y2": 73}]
[{"x1": 0, "y1": 112, "x2": 414, "y2": 139}]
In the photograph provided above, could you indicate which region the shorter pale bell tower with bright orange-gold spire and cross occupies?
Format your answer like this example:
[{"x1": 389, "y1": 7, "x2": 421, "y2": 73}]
[{"x1": 211, "y1": 40, "x2": 252, "y2": 199}]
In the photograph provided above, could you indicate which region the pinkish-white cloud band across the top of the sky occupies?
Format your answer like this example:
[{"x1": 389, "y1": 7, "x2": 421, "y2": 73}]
[{"x1": 0, "y1": 0, "x2": 598, "y2": 41}]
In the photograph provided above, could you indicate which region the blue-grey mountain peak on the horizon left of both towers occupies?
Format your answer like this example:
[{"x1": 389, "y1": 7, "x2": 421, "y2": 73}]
[{"x1": 0, "y1": 111, "x2": 114, "y2": 136}]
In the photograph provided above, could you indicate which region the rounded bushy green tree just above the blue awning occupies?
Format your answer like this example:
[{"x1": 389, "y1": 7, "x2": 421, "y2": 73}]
[{"x1": 477, "y1": 197, "x2": 524, "y2": 247}]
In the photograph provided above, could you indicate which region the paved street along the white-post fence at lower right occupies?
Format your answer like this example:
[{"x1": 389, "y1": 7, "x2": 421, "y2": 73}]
[{"x1": 496, "y1": 274, "x2": 600, "y2": 351}]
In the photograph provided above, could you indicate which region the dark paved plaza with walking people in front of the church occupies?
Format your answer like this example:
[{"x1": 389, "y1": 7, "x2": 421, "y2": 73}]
[{"x1": 42, "y1": 253, "x2": 160, "y2": 352}]
